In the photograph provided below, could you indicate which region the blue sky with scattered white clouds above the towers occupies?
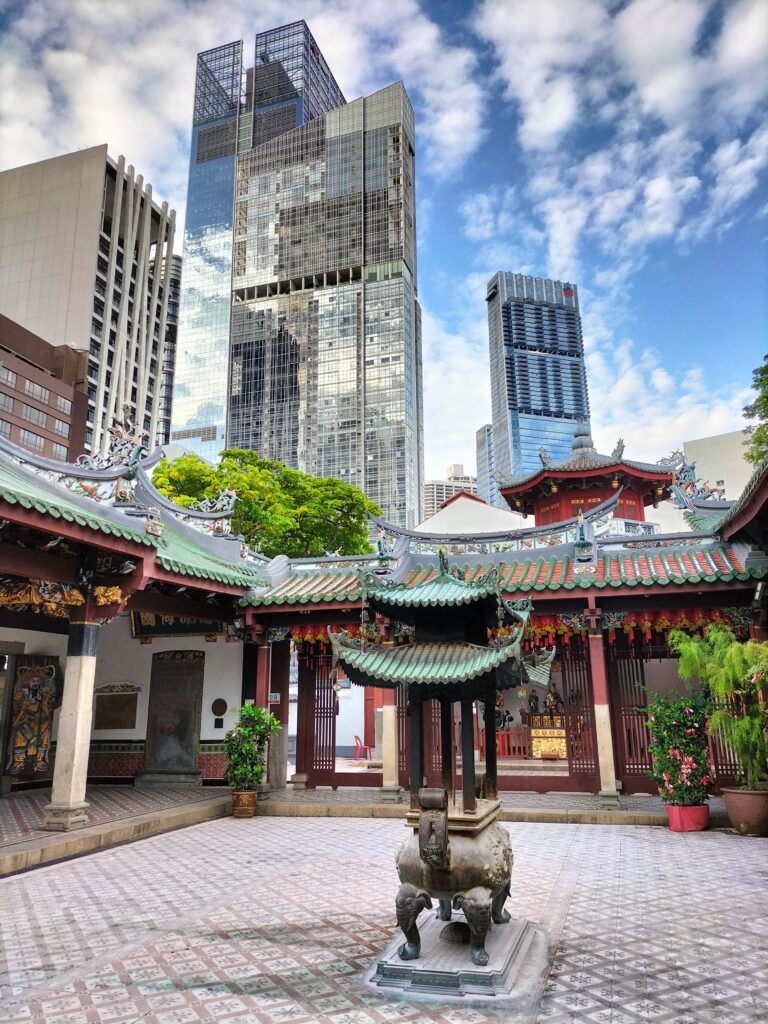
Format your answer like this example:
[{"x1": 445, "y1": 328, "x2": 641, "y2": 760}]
[{"x1": 0, "y1": 0, "x2": 768, "y2": 477}]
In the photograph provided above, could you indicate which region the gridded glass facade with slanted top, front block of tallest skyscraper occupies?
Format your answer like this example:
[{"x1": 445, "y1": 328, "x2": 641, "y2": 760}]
[{"x1": 227, "y1": 84, "x2": 423, "y2": 525}]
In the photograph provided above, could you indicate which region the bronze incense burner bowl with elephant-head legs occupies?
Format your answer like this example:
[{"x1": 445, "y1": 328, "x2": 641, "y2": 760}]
[{"x1": 395, "y1": 790, "x2": 512, "y2": 967}]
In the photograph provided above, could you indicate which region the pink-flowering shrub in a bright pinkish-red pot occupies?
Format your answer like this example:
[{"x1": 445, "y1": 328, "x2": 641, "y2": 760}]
[{"x1": 645, "y1": 686, "x2": 714, "y2": 831}]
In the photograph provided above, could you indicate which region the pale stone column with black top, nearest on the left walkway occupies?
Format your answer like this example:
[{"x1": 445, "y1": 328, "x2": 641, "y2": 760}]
[{"x1": 43, "y1": 623, "x2": 99, "y2": 831}]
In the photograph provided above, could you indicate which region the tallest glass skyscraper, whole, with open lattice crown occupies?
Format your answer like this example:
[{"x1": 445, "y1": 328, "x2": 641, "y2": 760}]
[{"x1": 171, "y1": 22, "x2": 423, "y2": 525}]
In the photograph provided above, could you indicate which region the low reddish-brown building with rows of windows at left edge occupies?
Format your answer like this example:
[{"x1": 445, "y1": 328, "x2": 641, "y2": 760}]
[{"x1": 0, "y1": 313, "x2": 88, "y2": 462}]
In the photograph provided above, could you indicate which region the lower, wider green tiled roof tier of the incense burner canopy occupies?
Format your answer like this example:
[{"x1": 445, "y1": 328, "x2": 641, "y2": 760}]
[{"x1": 331, "y1": 633, "x2": 520, "y2": 686}]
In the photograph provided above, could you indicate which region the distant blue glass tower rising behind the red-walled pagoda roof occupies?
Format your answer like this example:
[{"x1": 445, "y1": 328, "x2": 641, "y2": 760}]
[{"x1": 485, "y1": 270, "x2": 589, "y2": 478}]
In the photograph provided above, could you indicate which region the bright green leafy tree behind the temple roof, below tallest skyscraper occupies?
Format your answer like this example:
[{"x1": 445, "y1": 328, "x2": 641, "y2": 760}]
[{"x1": 153, "y1": 449, "x2": 381, "y2": 558}]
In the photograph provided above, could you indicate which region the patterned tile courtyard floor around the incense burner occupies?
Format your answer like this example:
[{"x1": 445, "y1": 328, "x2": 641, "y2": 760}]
[{"x1": 0, "y1": 817, "x2": 768, "y2": 1024}]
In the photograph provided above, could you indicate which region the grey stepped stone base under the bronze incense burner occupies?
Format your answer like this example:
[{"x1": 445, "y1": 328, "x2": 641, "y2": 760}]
[{"x1": 366, "y1": 910, "x2": 549, "y2": 1002}]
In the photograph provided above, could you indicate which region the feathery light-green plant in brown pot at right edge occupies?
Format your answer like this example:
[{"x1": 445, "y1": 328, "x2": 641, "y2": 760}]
[{"x1": 670, "y1": 626, "x2": 768, "y2": 836}]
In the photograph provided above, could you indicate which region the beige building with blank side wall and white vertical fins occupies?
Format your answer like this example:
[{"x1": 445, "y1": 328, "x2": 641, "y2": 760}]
[{"x1": 0, "y1": 145, "x2": 175, "y2": 451}]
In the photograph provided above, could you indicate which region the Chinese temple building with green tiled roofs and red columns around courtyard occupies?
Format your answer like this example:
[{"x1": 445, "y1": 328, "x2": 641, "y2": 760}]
[{"x1": 0, "y1": 419, "x2": 768, "y2": 828}]
